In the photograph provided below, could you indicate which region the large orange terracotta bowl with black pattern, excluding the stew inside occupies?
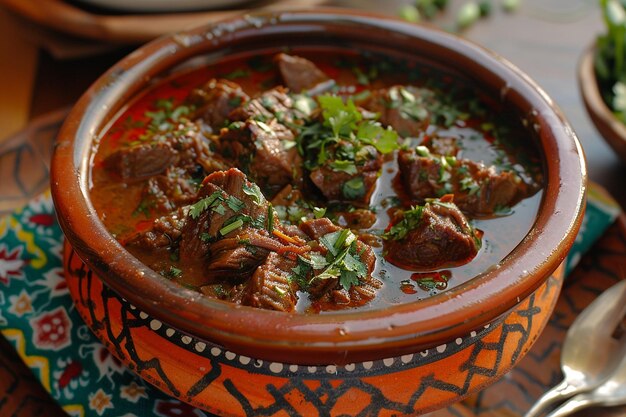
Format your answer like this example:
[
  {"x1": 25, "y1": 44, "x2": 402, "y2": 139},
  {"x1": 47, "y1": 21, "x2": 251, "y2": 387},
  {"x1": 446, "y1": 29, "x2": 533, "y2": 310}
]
[{"x1": 51, "y1": 10, "x2": 586, "y2": 416}]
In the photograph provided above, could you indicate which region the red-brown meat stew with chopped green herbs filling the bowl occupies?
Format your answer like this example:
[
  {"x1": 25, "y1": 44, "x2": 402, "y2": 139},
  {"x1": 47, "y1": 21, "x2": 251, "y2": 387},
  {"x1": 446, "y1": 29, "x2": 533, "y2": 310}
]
[{"x1": 91, "y1": 49, "x2": 543, "y2": 313}]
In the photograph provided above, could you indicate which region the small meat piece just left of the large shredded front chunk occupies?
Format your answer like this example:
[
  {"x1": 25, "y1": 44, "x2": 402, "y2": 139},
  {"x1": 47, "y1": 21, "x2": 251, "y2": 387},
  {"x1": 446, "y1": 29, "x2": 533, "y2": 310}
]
[{"x1": 121, "y1": 208, "x2": 187, "y2": 249}]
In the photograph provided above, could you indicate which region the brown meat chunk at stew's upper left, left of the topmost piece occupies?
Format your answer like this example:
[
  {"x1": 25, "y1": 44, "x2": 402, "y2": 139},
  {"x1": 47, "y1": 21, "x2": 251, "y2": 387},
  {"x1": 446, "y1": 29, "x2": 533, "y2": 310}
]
[{"x1": 187, "y1": 78, "x2": 250, "y2": 132}]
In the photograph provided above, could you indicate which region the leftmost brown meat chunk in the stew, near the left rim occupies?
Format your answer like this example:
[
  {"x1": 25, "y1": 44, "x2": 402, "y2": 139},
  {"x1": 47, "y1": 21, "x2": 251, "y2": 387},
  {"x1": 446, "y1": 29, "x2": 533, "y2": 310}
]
[{"x1": 103, "y1": 143, "x2": 178, "y2": 181}]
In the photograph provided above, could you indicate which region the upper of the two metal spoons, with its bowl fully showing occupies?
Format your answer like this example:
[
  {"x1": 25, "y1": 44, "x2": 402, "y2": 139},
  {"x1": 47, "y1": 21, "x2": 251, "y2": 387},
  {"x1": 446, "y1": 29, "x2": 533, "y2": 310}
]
[{"x1": 524, "y1": 281, "x2": 626, "y2": 417}]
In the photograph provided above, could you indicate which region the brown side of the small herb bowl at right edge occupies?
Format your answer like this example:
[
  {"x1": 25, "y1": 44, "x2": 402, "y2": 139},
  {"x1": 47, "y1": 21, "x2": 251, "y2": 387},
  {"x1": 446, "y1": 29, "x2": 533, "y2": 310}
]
[{"x1": 578, "y1": 46, "x2": 626, "y2": 161}]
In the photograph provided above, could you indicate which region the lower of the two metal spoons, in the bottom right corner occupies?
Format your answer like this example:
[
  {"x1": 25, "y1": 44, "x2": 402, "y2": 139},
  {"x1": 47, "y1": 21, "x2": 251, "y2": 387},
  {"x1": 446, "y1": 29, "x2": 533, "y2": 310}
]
[{"x1": 546, "y1": 348, "x2": 626, "y2": 417}]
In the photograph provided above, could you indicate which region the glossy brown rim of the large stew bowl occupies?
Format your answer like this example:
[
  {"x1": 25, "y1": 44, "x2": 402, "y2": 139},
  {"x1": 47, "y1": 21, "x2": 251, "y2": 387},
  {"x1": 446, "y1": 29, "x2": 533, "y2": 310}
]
[{"x1": 51, "y1": 9, "x2": 587, "y2": 364}]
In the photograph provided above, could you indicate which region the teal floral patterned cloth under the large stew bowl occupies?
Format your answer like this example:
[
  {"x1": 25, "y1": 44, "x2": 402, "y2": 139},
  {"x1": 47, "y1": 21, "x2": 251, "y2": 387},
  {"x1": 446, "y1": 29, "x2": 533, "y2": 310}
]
[{"x1": 0, "y1": 187, "x2": 619, "y2": 417}]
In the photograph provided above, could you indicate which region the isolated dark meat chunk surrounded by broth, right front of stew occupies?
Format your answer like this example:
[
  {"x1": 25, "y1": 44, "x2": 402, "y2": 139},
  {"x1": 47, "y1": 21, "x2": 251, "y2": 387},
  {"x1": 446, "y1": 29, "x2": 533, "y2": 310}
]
[{"x1": 384, "y1": 195, "x2": 481, "y2": 270}]
